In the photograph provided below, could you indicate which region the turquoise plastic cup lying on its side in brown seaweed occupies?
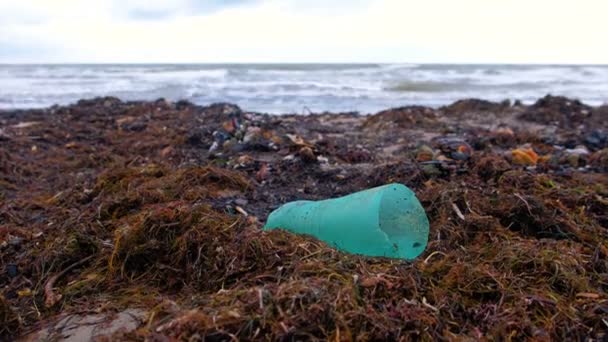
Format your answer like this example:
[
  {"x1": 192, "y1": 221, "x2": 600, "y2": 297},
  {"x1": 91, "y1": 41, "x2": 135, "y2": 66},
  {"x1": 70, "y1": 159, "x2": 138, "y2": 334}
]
[{"x1": 264, "y1": 183, "x2": 429, "y2": 260}]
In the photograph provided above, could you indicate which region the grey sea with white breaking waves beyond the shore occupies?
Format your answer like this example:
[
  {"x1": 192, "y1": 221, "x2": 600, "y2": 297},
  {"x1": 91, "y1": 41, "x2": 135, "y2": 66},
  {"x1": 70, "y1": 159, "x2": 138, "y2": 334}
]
[{"x1": 0, "y1": 64, "x2": 608, "y2": 114}]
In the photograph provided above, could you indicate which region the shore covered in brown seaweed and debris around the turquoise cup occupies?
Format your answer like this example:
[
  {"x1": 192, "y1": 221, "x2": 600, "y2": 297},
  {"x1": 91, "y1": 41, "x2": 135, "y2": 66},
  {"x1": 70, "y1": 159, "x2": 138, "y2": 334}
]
[{"x1": 0, "y1": 96, "x2": 608, "y2": 340}]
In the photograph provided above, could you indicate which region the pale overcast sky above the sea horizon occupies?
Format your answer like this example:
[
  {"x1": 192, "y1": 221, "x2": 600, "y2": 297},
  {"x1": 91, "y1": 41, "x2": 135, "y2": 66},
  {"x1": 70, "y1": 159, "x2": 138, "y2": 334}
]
[{"x1": 0, "y1": 0, "x2": 608, "y2": 64}]
